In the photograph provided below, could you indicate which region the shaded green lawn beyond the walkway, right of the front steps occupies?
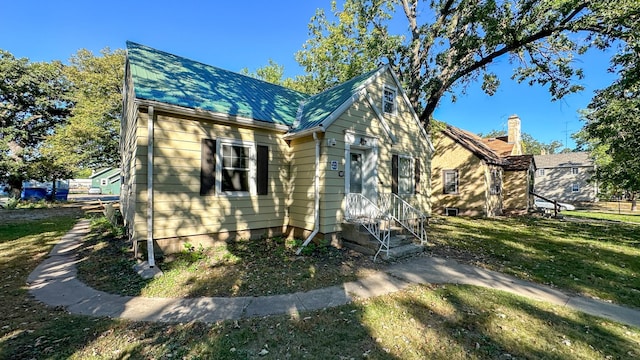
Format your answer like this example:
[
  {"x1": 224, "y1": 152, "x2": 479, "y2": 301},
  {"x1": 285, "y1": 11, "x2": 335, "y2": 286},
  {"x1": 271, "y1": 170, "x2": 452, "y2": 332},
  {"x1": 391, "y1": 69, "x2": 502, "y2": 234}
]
[{"x1": 430, "y1": 217, "x2": 640, "y2": 308}]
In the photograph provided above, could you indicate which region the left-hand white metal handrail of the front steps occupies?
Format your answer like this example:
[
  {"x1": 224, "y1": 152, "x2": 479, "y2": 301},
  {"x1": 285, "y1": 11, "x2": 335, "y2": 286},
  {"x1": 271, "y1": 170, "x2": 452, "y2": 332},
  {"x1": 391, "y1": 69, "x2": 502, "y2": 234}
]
[{"x1": 345, "y1": 193, "x2": 391, "y2": 261}]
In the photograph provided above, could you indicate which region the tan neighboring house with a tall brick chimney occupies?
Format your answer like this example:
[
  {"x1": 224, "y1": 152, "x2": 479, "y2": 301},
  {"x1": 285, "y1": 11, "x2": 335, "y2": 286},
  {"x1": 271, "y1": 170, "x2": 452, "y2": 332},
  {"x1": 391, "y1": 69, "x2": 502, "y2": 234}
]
[{"x1": 431, "y1": 116, "x2": 535, "y2": 216}]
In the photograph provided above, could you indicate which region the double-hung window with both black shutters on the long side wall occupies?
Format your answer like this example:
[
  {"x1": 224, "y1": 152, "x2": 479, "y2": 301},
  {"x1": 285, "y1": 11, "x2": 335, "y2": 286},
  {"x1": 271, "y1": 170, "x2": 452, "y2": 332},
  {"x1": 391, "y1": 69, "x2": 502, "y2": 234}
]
[{"x1": 200, "y1": 139, "x2": 269, "y2": 196}]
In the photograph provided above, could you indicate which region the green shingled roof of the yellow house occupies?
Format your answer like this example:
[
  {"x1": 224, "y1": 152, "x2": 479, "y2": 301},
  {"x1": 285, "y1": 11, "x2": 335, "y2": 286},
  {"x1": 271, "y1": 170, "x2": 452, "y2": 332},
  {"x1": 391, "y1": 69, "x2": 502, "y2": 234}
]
[{"x1": 127, "y1": 41, "x2": 380, "y2": 133}]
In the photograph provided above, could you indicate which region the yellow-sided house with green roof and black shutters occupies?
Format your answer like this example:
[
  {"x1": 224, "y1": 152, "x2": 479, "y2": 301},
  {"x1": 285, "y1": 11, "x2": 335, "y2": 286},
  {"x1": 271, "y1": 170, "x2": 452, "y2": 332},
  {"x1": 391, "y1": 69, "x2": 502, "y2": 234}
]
[{"x1": 121, "y1": 42, "x2": 433, "y2": 262}]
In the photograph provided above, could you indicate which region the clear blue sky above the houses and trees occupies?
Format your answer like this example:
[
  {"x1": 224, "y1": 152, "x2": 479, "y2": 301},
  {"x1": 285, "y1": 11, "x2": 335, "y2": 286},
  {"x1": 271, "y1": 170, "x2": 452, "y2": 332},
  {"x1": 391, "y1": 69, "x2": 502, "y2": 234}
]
[{"x1": 0, "y1": 0, "x2": 613, "y2": 147}]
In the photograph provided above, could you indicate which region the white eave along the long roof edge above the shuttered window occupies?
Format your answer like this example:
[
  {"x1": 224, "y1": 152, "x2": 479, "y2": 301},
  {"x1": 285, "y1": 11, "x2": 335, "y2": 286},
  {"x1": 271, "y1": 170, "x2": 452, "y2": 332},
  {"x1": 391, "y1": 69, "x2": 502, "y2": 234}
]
[{"x1": 135, "y1": 98, "x2": 289, "y2": 133}]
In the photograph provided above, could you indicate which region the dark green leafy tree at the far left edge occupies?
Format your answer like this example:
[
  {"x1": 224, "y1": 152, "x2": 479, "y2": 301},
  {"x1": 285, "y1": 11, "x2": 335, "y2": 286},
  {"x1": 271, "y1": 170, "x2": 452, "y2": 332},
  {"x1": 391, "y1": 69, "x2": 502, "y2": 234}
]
[{"x1": 0, "y1": 50, "x2": 72, "y2": 193}]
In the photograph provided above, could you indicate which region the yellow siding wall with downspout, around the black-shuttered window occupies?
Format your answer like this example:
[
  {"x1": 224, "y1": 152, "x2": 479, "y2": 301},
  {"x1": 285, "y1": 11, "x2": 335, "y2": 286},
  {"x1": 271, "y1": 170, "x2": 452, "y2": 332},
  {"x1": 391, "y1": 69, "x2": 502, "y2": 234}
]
[{"x1": 128, "y1": 110, "x2": 291, "y2": 252}]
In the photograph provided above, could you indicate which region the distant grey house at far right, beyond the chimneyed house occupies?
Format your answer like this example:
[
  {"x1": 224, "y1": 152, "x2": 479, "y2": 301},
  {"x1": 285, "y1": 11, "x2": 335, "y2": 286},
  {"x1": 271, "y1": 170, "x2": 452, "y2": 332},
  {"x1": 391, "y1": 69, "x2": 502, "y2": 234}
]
[{"x1": 534, "y1": 152, "x2": 598, "y2": 202}]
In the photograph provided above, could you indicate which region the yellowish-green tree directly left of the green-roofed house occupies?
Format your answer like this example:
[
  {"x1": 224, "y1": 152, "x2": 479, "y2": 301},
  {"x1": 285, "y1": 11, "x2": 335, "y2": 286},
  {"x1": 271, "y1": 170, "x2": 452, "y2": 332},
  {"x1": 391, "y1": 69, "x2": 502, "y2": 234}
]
[{"x1": 47, "y1": 48, "x2": 125, "y2": 172}]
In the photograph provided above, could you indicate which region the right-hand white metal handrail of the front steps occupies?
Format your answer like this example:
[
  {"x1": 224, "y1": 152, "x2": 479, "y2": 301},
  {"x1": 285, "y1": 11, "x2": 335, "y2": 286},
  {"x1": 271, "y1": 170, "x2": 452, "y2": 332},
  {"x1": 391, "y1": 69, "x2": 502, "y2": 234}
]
[{"x1": 378, "y1": 193, "x2": 427, "y2": 245}]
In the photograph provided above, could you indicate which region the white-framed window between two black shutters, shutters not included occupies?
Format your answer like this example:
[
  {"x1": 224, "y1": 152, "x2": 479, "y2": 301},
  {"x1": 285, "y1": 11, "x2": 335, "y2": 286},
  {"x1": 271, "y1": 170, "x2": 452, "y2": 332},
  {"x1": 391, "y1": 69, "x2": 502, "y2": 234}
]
[{"x1": 216, "y1": 139, "x2": 256, "y2": 195}]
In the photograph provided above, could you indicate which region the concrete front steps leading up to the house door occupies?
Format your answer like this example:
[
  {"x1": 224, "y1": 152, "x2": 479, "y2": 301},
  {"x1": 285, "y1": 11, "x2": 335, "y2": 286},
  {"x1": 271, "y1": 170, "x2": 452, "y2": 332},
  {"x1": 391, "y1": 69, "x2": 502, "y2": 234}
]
[{"x1": 342, "y1": 222, "x2": 424, "y2": 260}]
